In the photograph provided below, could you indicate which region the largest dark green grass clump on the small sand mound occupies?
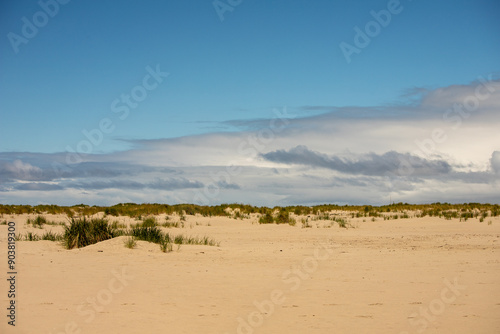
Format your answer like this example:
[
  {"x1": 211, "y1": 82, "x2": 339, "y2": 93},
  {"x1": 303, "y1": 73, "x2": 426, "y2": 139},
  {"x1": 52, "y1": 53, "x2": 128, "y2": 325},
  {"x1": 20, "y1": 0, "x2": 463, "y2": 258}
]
[{"x1": 63, "y1": 217, "x2": 116, "y2": 249}]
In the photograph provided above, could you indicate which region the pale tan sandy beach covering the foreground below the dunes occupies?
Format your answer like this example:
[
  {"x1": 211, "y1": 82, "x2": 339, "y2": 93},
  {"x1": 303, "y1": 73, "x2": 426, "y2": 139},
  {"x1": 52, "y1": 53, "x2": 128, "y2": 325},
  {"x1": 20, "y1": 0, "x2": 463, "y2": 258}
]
[{"x1": 0, "y1": 215, "x2": 500, "y2": 334}]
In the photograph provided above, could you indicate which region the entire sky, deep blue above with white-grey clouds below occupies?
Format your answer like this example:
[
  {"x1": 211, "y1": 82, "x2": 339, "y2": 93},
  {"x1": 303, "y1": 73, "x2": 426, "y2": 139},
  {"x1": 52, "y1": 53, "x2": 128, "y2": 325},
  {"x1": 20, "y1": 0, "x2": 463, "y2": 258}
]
[{"x1": 0, "y1": 0, "x2": 500, "y2": 205}]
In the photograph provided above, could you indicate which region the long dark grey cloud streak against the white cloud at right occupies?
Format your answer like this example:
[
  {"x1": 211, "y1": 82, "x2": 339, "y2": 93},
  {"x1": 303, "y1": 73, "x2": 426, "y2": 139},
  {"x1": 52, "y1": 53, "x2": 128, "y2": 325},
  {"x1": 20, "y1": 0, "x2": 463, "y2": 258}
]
[{"x1": 261, "y1": 145, "x2": 451, "y2": 176}]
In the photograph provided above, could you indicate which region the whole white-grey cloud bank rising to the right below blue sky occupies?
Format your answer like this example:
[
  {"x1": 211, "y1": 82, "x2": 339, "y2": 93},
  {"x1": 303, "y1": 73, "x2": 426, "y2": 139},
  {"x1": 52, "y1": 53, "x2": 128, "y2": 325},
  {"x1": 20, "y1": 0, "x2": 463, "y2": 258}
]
[{"x1": 0, "y1": 80, "x2": 500, "y2": 206}]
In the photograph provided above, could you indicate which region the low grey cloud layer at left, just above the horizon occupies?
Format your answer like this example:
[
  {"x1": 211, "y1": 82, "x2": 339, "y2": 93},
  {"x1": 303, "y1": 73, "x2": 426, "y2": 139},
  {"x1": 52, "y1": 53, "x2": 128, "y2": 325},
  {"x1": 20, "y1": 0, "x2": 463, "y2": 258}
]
[{"x1": 0, "y1": 152, "x2": 204, "y2": 192}]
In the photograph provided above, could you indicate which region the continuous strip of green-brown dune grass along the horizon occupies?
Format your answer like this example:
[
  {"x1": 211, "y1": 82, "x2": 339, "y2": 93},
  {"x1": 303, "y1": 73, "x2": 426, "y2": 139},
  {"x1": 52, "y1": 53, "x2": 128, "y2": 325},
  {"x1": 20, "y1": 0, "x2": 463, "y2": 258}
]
[{"x1": 0, "y1": 202, "x2": 500, "y2": 227}]
